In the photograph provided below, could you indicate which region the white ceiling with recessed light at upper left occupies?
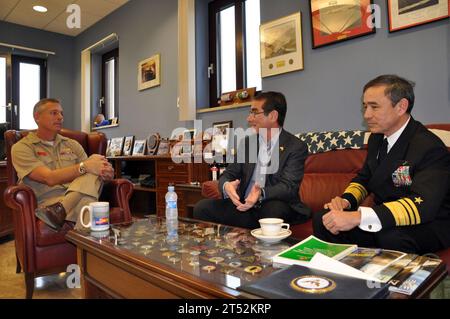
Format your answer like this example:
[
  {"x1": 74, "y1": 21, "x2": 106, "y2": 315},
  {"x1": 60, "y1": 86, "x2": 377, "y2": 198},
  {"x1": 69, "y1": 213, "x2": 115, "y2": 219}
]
[{"x1": 0, "y1": 0, "x2": 129, "y2": 36}]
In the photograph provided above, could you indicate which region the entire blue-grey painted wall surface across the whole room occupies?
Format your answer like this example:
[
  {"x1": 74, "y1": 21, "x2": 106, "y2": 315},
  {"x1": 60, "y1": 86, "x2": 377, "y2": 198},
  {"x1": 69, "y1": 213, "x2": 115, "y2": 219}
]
[{"x1": 0, "y1": 0, "x2": 450, "y2": 138}]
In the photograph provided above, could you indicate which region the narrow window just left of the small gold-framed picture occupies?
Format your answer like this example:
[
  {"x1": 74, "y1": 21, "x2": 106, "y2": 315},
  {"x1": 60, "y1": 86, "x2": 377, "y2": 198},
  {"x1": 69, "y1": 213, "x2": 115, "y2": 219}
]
[{"x1": 101, "y1": 48, "x2": 119, "y2": 119}]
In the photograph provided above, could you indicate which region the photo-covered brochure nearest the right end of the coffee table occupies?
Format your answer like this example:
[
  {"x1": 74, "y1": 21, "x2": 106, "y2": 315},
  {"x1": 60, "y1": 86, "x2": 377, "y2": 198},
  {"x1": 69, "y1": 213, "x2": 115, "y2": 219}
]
[{"x1": 389, "y1": 256, "x2": 441, "y2": 295}]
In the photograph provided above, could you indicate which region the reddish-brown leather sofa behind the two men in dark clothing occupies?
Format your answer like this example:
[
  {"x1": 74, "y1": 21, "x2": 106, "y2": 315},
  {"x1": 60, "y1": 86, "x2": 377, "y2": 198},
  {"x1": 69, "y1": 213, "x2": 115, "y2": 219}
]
[{"x1": 202, "y1": 124, "x2": 450, "y2": 272}]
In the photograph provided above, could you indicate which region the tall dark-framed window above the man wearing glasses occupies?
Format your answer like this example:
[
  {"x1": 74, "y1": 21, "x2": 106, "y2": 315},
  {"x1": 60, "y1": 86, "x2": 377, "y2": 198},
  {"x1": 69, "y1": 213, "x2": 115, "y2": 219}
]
[{"x1": 208, "y1": 0, "x2": 262, "y2": 106}]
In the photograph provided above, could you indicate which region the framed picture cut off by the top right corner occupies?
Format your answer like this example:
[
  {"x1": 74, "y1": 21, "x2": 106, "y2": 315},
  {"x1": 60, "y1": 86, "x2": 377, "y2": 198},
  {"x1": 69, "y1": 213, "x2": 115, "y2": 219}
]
[{"x1": 388, "y1": 0, "x2": 450, "y2": 32}]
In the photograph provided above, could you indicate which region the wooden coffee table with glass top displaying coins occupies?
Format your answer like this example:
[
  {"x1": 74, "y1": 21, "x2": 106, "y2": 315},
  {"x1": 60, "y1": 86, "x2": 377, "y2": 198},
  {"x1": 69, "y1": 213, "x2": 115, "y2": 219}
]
[{"x1": 66, "y1": 216, "x2": 446, "y2": 298}]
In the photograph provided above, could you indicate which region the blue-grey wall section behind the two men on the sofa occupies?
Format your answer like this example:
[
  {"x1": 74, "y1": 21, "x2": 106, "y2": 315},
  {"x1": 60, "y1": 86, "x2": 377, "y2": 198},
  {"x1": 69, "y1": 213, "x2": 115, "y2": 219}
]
[{"x1": 198, "y1": 0, "x2": 450, "y2": 132}]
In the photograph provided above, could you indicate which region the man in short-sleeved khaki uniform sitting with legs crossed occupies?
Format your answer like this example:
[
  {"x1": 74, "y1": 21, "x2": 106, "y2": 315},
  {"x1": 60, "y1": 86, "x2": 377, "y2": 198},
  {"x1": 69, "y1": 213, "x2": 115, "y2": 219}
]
[{"x1": 12, "y1": 99, "x2": 114, "y2": 230}]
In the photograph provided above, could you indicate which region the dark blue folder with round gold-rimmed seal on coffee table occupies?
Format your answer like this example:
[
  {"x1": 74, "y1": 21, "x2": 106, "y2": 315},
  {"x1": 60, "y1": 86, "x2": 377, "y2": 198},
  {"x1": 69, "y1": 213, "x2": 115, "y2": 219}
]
[{"x1": 237, "y1": 265, "x2": 389, "y2": 299}]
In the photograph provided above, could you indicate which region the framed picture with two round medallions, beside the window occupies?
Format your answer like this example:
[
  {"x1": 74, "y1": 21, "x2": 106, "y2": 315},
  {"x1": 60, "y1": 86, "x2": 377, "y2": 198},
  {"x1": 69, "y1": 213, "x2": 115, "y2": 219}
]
[{"x1": 259, "y1": 12, "x2": 303, "y2": 78}]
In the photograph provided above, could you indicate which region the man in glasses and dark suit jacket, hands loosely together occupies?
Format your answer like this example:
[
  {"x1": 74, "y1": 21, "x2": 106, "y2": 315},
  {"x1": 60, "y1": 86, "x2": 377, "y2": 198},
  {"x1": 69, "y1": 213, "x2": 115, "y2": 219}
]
[{"x1": 194, "y1": 92, "x2": 311, "y2": 228}]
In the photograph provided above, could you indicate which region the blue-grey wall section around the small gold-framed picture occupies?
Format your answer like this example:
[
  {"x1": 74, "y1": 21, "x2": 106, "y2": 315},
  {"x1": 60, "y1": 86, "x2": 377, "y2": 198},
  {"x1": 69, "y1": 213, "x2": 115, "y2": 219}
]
[{"x1": 74, "y1": 0, "x2": 193, "y2": 139}]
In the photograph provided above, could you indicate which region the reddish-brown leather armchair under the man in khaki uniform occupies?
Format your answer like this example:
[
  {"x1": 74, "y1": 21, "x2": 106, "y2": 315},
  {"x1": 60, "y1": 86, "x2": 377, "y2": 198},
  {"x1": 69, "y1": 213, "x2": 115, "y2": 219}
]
[{"x1": 4, "y1": 129, "x2": 133, "y2": 298}]
